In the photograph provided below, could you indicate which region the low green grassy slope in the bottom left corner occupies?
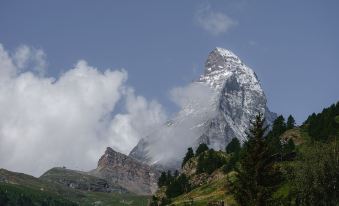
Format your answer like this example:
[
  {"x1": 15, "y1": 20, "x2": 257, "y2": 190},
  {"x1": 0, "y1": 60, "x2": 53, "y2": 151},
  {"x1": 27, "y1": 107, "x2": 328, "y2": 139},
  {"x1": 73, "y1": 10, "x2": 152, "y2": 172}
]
[{"x1": 0, "y1": 169, "x2": 149, "y2": 206}]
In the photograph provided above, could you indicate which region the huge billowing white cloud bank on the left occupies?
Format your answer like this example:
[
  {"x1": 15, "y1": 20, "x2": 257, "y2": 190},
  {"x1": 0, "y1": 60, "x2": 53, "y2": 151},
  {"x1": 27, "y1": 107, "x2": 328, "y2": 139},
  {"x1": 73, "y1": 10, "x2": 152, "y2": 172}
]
[{"x1": 0, "y1": 44, "x2": 166, "y2": 175}]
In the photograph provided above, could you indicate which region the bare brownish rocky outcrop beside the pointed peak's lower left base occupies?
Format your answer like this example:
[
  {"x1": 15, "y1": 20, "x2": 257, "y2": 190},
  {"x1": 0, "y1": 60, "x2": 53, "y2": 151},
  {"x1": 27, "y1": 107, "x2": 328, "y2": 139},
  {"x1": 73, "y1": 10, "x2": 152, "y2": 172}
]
[{"x1": 90, "y1": 147, "x2": 159, "y2": 195}]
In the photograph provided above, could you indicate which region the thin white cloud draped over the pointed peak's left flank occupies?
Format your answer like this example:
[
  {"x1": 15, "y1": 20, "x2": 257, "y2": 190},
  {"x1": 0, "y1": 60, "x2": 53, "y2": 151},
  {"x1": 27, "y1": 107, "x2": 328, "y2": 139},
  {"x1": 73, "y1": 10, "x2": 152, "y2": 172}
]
[{"x1": 146, "y1": 82, "x2": 217, "y2": 165}]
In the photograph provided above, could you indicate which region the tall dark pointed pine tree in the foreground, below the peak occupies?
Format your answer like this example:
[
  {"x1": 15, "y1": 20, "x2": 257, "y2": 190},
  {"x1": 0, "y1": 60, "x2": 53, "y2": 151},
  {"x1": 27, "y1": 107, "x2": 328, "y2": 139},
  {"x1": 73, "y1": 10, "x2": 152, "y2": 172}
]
[{"x1": 230, "y1": 114, "x2": 281, "y2": 206}]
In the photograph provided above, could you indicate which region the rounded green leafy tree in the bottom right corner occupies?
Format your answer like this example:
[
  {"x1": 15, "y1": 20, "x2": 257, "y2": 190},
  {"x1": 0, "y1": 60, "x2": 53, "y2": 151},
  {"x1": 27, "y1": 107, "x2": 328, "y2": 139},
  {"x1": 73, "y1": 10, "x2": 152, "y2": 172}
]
[{"x1": 291, "y1": 142, "x2": 339, "y2": 206}]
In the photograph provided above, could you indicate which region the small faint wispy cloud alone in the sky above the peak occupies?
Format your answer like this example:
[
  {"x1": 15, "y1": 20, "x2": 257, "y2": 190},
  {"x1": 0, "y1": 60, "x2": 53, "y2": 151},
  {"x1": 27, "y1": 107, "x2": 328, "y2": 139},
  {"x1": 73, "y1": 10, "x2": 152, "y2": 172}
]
[{"x1": 195, "y1": 5, "x2": 237, "y2": 36}]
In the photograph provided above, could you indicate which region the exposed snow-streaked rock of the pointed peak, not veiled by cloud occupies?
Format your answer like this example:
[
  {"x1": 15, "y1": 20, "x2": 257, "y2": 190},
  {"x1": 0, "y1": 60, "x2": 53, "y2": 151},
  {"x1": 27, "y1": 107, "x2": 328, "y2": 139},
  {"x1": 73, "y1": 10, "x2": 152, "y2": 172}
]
[{"x1": 199, "y1": 48, "x2": 276, "y2": 149}]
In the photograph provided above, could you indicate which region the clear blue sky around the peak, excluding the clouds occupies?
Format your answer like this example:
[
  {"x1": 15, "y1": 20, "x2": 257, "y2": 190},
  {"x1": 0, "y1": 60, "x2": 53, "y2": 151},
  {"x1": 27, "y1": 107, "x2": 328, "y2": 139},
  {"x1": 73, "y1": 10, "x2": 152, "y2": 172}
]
[{"x1": 0, "y1": 0, "x2": 339, "y2": 122}]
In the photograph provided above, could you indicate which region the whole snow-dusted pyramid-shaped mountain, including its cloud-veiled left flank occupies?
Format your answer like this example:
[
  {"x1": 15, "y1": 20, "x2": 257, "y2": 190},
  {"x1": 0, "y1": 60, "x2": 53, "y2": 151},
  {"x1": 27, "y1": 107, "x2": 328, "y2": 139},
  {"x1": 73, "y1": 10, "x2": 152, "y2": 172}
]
[{"x1": 129, "y1": 48, "x2": 276, "y2": 168}]
